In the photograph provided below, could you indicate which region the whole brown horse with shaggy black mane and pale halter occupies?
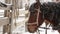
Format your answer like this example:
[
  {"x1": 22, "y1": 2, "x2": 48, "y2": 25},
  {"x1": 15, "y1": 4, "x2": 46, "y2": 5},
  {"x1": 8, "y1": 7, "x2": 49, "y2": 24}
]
[{"x1": 27, "y1": 2, "x2": 60, "y2": 33}]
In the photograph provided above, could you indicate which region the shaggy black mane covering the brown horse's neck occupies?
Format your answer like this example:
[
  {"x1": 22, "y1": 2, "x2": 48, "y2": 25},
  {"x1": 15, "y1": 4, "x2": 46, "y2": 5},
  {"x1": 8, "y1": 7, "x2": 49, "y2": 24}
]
[{"x1": 40, "y1": 2, "x2": 60, "y2": 30}]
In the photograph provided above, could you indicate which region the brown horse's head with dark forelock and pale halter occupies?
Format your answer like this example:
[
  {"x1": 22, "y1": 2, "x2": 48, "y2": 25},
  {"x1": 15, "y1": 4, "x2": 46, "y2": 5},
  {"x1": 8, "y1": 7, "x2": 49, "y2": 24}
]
[{"x1": 27, "y1": 3, "x2": 43, "y2": 33}]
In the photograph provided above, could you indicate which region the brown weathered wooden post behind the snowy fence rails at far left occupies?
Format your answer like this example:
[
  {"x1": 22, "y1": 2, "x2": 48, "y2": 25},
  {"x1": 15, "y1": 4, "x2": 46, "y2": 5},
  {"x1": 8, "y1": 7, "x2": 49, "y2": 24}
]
[{"x1": 3, "y1": 0, "x2": 11, "y2": 34}]
